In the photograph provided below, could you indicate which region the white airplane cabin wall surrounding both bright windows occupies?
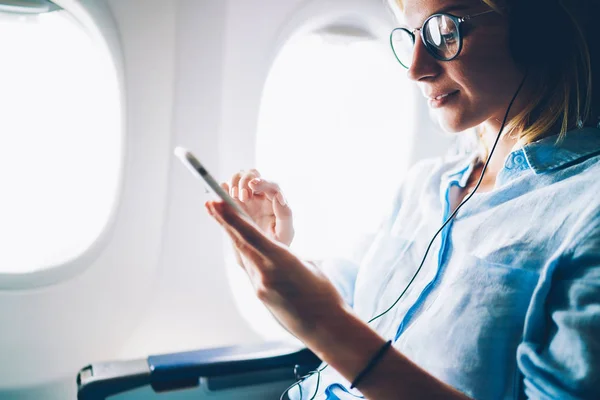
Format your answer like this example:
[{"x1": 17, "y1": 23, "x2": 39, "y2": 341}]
[{"x1": 0, "y1": 0, "x2": 448, "y2": 400}]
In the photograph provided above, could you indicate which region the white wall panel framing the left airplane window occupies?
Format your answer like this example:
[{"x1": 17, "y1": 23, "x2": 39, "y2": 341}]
[{"x1": 0, "y1": 0, "x2": 177, "y2": 399}]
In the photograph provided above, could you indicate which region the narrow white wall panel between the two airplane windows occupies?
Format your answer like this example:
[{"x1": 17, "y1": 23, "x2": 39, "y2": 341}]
[{"x1": 116, "y1": 0, "x2": 260, "y2": 357}]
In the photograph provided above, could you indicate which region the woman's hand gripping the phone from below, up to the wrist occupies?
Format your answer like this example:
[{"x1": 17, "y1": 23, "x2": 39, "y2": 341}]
[{"x1": 205, "y1": 201, "x2": 346, "y2": 341}]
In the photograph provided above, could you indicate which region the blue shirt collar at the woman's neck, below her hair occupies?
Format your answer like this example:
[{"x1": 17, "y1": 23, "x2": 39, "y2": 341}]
[{"x1": 524, "y1": 128, "x2": 600, "y2": 174}]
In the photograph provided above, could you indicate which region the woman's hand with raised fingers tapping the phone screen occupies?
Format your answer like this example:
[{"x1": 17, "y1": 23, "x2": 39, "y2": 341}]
[{"x1": 221, "y1": 169, "x2": 294, "y2": 265}]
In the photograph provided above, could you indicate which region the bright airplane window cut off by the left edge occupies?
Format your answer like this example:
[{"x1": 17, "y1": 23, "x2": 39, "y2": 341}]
[{"x1": 0, "y1": 10, "x2": 122, "y2": 274}]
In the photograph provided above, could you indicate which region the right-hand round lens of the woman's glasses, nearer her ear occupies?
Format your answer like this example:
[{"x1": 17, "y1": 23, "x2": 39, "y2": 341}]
[{"x1": 423, "y1": 15, "x2": 460, "y2": 60}]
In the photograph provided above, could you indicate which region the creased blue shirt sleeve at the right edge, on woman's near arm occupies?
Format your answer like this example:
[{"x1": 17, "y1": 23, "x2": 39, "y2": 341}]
[{"x1": 517, "y1": 205, "x2": 600, "y2": 400}]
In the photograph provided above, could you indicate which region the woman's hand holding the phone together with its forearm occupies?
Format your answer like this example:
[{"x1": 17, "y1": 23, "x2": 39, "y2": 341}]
[{"x1": 206, "y1": 202, "x2": 474, "y2": 400}]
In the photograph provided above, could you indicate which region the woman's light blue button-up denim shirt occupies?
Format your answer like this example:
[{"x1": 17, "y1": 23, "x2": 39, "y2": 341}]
[{"x1": 290, "y1": 128, "x2": 600, "y2": 400}]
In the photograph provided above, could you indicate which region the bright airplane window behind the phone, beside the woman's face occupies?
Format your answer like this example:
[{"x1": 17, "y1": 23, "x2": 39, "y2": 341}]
[{"x1": 257, "y1": 33, "x2": 415, "y2": 259}]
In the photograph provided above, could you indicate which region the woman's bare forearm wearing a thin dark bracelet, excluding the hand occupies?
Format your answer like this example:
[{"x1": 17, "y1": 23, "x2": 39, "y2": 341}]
[{"x1": 304, "y1": 304, "x2": 468, "y2": 400}]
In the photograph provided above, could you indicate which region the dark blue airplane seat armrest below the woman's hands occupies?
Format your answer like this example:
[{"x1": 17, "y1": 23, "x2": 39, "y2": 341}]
[{"x1": 77, "y1": 342, "x2": 321, "y2": 400}]
